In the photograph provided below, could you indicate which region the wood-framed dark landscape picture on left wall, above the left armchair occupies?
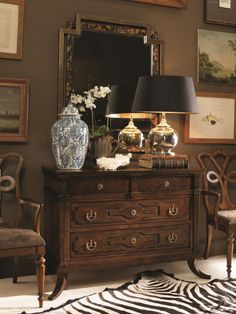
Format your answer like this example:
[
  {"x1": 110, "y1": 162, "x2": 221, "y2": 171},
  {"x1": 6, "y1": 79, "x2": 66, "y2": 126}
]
[{"x1": 0, "y1": 78, "x2": 29, "y2": 143}]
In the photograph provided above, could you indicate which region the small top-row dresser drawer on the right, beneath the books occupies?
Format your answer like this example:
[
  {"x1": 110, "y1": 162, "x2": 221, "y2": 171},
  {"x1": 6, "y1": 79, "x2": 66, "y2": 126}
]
[{"x1": 139, "y1": 176, "x2": 191, "y2": 192}]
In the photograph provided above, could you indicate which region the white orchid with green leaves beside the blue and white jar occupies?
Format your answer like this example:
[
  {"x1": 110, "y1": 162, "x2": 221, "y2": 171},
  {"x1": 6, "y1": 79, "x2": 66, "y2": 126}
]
[{"x1": 70, "y1": 86, "x2": 111, "y2": 138}]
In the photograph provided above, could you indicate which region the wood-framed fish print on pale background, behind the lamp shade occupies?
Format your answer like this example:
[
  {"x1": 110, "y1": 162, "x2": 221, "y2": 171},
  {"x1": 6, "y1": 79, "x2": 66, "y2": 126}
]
[{"x1": 185, "y1": 93, "x2": 236, "y2": 144}]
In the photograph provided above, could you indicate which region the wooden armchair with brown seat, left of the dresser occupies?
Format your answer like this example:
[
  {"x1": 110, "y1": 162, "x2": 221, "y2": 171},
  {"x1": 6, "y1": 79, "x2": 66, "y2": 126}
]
[{"x1": 0, "y1": 153, "x2": 45, "y2": 307}]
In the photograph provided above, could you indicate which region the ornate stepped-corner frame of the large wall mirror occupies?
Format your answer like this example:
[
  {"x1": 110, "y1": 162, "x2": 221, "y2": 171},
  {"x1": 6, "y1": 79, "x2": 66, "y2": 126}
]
[{"x1": 58, "y1": 14, "x2": 163, "y2": 112}]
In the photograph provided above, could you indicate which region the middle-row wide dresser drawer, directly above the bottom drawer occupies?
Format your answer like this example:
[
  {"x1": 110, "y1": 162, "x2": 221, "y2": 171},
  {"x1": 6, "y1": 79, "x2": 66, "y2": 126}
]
[{"x1": 70, "y1": 197, "x2": 190, "y2": 228}]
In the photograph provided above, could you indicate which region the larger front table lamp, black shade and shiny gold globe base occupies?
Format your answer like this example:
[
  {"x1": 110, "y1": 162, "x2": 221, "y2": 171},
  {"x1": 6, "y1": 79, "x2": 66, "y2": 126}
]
[{"x1": 131, "y1": 75, "x2": 198, "y2": 155}]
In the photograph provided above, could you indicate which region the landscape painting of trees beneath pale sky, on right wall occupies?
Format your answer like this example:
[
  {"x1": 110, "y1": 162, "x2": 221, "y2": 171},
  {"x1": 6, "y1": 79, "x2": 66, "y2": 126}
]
[{"x1": 198, "y1": 30, "x2": 236, "y2": 85}]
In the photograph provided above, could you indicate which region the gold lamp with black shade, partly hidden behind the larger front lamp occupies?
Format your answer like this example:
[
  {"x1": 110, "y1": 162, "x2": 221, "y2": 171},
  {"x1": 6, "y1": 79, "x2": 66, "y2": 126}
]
[{"x1": 106, "y1": 84, "x2": 151, "y2": 148}]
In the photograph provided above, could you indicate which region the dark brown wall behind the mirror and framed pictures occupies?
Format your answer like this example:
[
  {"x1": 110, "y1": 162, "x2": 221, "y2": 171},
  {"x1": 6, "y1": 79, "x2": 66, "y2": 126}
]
[{"x1": 0, "y1": 0, "x2": 235, "y2": 274}]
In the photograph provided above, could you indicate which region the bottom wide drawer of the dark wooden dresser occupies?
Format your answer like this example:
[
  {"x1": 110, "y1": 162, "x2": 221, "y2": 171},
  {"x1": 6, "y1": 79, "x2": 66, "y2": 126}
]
[{"x1": 70, "y1": 224, "x2": 190, "y2": 258}]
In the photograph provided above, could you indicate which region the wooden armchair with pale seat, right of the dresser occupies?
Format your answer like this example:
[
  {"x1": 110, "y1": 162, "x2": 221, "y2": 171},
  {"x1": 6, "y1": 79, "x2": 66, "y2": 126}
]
[{"x1": 197, "y1": 151, "x2": 236, "y2": 278}]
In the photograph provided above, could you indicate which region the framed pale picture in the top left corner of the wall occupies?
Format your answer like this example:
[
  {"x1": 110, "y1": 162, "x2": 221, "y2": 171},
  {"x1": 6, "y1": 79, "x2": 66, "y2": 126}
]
[{"x1": 0, "y1": 0, "x2": 24, "y2": 60}]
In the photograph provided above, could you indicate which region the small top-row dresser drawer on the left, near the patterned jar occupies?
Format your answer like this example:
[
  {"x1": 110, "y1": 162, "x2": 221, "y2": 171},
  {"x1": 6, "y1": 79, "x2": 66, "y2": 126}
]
[{"x1": 67, "y1": 176, "x2": 130, "y2": 195}]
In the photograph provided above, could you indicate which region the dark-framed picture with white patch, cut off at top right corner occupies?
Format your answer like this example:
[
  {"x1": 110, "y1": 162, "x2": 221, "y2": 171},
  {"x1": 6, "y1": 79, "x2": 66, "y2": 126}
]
[{"x1": 204, "y1": 0, "x2": 236, "y2": 27}]
